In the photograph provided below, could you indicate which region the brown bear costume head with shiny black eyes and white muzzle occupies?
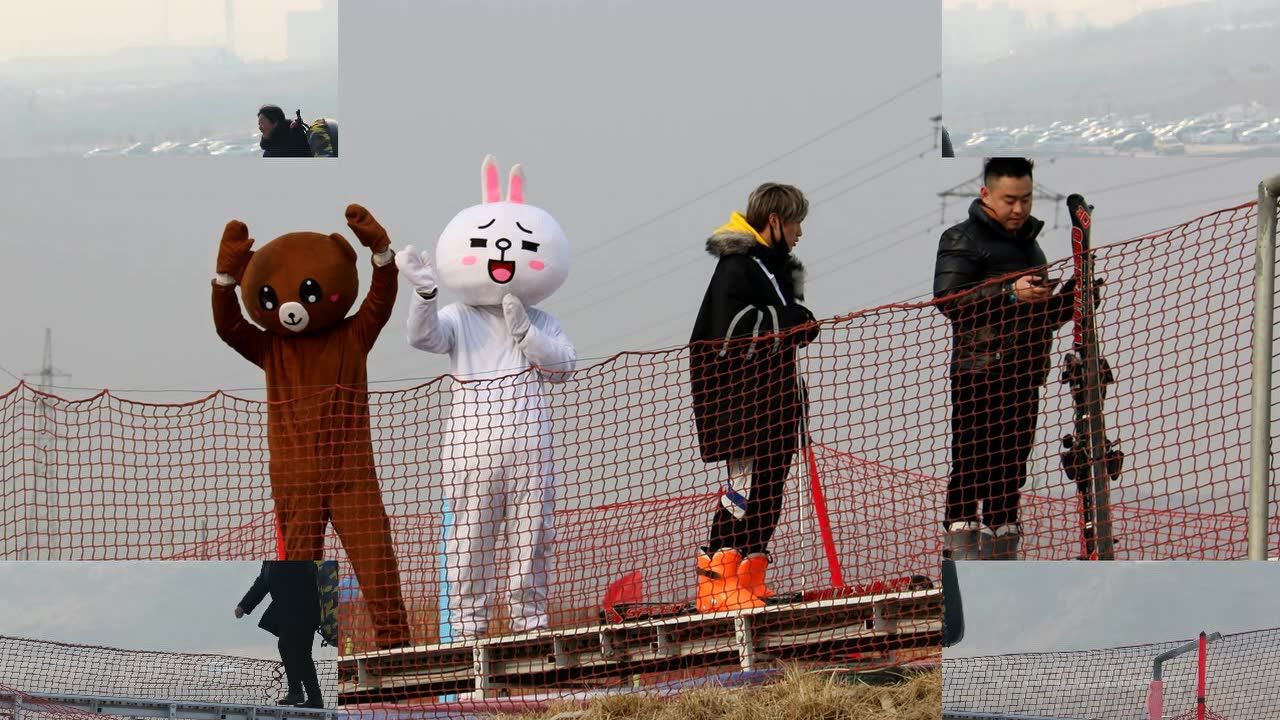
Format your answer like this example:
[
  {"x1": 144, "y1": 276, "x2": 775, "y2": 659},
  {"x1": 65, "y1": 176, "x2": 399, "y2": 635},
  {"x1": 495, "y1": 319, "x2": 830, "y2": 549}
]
[{"x1": 241, "y1": 232, "x2": 360, "y2": 336}]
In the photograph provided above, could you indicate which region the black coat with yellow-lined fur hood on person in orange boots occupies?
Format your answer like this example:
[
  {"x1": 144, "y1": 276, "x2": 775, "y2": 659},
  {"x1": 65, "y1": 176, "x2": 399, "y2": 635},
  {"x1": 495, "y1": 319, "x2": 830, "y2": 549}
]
[{"x1": 689, "y1": 222, "x2": 818, "y2": 462}]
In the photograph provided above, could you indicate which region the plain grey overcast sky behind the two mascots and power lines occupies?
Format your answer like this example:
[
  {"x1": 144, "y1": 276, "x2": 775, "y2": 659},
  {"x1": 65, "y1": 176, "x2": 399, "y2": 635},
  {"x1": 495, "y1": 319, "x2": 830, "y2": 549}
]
[{"x1": 0, "y1": 0, "x2": 1280, "y2": 398}]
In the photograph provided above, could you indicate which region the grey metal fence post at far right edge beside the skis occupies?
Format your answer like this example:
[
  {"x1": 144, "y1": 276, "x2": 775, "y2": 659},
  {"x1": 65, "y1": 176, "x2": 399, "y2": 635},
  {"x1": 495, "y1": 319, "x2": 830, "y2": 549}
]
[{"x1": 1248, "y1": 176, "x2": 1280, "y2": 560}]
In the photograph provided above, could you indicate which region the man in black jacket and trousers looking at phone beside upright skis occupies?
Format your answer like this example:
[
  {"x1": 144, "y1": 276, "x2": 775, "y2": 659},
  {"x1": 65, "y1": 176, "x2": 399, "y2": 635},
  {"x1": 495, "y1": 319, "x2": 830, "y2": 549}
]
[{"x1": 933, "y1": 158, "x2": 1075, "y2": 560}]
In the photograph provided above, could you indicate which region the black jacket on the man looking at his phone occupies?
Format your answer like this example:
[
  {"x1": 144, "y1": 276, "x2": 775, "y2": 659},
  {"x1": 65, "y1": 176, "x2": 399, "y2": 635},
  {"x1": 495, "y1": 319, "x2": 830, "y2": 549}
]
[{"x1": 933, "y1": 200, "x2": 1074, "y2": 386}]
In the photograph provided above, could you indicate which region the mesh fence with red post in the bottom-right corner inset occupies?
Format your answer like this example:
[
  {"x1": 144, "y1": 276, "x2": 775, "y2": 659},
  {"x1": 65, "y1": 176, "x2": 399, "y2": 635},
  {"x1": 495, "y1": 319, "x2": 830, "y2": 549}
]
[{"x1": 942, "y1": 628, "x2": 1280, "y2": 720}]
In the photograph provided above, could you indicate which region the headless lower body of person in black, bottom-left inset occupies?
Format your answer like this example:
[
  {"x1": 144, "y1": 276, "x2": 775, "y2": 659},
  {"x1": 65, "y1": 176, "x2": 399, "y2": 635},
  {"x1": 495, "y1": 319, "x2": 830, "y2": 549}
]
[{"x1": 236, "y1": 560, "x2": 324, "y2": 707}]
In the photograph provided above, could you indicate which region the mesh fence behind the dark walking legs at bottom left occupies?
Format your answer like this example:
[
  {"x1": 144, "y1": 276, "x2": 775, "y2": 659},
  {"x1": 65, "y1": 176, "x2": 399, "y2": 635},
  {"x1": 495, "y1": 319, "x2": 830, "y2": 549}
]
[{"x1": 0, "y1": 637, "x2": 337, "y2": 706}]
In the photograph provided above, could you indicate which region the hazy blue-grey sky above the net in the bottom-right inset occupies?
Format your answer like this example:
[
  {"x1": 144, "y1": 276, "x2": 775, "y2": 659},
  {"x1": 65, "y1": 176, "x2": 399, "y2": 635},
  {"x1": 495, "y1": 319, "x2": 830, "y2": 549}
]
[{"x1": 943, "y1": 561, "x2": 1280, "y2": 657}]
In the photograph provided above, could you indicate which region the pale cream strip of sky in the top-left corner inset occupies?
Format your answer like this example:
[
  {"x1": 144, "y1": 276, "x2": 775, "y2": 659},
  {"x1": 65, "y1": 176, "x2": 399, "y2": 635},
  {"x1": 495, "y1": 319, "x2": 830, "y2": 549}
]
[{"x1": 0, "y1": 0, "x2": 321, "y2": 60}]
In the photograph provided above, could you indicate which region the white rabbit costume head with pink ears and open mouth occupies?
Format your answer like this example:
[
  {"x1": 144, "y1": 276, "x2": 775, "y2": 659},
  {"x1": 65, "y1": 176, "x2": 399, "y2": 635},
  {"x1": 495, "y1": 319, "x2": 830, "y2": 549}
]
[{"x1": 435, "y1": 155, "x2": 570, "y2": 306}]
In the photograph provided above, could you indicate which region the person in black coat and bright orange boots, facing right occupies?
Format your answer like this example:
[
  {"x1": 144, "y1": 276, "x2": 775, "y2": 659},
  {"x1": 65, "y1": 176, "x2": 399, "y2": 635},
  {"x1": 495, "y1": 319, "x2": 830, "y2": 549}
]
[{"x1": 689, "y1": 183, "x2": 818, "y2": 612}]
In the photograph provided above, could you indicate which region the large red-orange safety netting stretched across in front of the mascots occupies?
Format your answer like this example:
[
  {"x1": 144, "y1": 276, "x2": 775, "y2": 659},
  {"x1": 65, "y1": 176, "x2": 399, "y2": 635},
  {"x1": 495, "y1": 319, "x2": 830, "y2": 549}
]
[{"x1": 0, "y1": 198, "x2": 1280, "y2": 707}]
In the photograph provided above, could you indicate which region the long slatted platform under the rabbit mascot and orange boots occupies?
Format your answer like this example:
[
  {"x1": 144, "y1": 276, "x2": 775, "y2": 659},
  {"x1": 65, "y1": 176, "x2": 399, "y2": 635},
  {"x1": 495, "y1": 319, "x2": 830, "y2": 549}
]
[{"x1": 338, "y1": 588, "x2": 942, "y2": 706}]
